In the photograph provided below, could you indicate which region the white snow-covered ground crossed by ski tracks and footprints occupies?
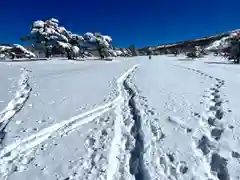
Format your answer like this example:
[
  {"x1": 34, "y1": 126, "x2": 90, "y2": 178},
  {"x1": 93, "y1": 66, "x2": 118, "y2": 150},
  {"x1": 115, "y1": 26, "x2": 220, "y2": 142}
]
[{"x1": 0, "y1": 56, "x2": 240, "y2": 180}]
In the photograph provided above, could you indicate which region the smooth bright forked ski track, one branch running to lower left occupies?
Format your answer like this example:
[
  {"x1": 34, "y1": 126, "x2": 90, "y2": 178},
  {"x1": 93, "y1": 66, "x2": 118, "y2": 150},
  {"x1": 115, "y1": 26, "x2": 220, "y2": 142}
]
[{"x1": 0, "y1": 65, "x2": 139, "y2": 180}]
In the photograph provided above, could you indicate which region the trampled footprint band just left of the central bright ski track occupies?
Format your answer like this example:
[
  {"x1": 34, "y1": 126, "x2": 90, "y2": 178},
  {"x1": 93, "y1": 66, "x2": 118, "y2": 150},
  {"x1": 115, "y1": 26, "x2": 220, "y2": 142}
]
[{"x1": 68, "y1": 112, "x2": 114, "y2": 180}]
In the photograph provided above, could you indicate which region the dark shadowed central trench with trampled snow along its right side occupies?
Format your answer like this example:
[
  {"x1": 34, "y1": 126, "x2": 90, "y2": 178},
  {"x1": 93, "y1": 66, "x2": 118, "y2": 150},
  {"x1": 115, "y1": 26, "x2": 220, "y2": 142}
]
[{"x1": 125, "y1": 77, "x2": 174, "y2": 180}]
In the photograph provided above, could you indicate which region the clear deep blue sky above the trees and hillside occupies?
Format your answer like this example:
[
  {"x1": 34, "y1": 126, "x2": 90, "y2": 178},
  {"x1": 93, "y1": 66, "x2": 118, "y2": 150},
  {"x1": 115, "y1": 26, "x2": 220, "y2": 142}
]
[{"x1": 0, "y1": 0, "x2": 240, "y2": 47}]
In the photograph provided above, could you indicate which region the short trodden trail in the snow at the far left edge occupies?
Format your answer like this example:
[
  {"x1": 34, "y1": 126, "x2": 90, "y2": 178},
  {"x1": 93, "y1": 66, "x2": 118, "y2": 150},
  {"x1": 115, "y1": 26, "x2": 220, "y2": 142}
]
[{"x1": 0, "y1": 68, "x2": 32, "y2": 144}]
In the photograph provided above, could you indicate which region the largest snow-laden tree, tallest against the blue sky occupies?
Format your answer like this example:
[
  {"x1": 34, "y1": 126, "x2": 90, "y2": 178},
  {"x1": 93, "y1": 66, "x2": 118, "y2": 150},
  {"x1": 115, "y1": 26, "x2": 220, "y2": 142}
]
[{"x1": 23, "y1": 18, "x2": 83, "y2": 59}]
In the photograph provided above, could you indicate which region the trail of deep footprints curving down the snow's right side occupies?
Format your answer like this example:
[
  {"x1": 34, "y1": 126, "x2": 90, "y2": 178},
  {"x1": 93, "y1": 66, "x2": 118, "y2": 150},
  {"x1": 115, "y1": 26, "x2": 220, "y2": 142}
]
[{"x1": 178, "y1": 66, "x2": 230, "y2": 180}]
